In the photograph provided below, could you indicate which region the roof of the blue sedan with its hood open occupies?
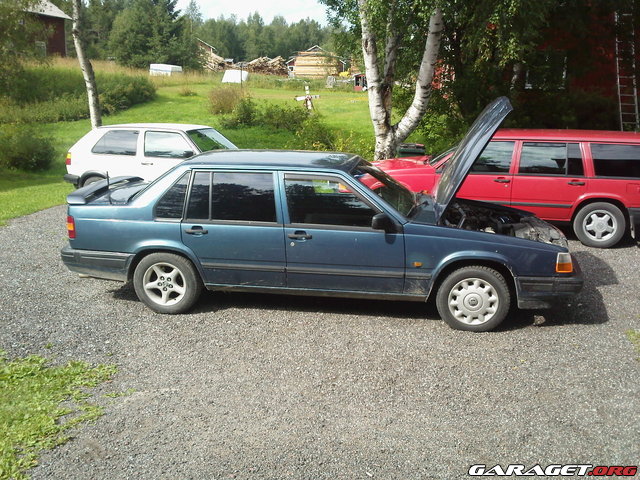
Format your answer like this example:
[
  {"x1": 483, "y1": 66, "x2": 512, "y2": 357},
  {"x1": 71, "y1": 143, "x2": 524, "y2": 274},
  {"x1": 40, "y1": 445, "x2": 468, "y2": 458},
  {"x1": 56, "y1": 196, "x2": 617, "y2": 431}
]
[{"x1": 181, "y1": 149, "x2": 361, "y2": 172}]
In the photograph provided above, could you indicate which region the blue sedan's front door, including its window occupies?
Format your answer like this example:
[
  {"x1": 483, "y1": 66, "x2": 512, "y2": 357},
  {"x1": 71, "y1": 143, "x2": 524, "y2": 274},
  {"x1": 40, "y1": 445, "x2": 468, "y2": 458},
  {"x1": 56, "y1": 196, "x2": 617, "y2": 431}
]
[{"x1": 283, "y1": 173, "x2": 404, "y2": 293}]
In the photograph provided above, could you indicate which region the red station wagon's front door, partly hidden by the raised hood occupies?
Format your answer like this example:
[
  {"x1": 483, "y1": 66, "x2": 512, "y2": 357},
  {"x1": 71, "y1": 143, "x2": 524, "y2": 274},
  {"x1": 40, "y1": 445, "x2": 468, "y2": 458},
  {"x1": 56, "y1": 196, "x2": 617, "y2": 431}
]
[{"x1": 458, "y1": 141, "x2": 515, "y2": 205}]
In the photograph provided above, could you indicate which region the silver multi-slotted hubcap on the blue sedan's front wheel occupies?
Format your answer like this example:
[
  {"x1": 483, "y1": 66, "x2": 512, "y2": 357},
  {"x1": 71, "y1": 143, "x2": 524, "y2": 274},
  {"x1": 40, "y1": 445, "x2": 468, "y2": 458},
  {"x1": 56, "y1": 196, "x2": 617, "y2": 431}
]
[{"x1": 449, "y1": 278, "x2": 500, "y2": 325}]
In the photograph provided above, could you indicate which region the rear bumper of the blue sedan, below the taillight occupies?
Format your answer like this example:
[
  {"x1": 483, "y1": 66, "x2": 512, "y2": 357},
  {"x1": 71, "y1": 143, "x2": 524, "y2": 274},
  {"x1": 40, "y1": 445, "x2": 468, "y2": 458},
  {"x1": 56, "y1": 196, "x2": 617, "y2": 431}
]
[{"x1": 60, "y1": 247, "x2": 134, "y2": 282}]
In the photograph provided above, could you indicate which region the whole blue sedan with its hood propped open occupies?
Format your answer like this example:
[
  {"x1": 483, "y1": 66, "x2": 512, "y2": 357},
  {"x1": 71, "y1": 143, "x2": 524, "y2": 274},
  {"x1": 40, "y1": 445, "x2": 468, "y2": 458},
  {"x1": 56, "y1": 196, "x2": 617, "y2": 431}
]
[{"x1": 62, "y1": 98, "x2": 583, "y2": 331}]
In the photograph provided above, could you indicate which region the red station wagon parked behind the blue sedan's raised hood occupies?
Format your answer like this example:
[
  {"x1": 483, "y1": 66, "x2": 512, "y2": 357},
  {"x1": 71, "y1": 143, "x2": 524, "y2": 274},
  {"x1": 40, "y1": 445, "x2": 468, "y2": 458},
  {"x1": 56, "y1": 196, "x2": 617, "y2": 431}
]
[{"x1": 375, "y1": 129, "x2": 640, "y2": 248}]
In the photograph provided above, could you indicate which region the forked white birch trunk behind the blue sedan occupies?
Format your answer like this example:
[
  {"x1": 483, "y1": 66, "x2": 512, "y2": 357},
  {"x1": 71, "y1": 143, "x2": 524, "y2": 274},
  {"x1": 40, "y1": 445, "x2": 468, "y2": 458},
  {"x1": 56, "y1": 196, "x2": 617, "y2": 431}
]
[{"x1": 358, "y1": 0, "x2": 442, "y2": 160}]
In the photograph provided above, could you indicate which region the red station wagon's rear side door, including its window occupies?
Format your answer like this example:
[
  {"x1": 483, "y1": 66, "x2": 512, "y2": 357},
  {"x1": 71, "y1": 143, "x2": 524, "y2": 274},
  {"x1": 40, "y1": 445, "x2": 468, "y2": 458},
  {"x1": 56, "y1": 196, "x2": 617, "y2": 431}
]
[{"x1": 511, "y1": 142, "x2": 588, "y2": 221}]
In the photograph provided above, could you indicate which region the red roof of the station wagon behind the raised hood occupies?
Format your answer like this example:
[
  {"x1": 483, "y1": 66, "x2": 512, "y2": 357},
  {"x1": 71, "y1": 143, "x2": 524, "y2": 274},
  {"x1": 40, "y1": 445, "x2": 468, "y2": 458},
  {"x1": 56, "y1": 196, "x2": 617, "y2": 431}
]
[{"x1": 493, "y1": 128, "x2": 640, "y2": 143}]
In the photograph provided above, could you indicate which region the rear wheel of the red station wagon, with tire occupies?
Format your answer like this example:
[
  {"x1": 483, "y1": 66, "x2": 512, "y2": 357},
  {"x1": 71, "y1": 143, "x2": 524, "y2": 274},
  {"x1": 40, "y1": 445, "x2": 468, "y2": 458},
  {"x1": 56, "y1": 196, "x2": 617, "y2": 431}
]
[{"x1": 573, "y1": 202, "x2": 627, "y2": 248}]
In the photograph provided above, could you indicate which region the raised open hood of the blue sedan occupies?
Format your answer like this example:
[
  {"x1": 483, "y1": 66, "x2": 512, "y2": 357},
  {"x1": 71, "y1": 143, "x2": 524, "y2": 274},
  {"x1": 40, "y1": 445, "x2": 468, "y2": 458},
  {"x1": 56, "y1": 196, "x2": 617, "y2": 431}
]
[{"x1": 433, "y1": 97, "x2": 513, "y2": 223}]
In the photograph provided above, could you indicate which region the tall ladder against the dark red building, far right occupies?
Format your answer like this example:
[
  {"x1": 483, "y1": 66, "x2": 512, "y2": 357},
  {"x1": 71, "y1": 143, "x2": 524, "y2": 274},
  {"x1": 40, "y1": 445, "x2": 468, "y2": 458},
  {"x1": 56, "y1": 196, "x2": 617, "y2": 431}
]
[{"x1": 615, "y1": 12, "x2": 640, "y2": 130}]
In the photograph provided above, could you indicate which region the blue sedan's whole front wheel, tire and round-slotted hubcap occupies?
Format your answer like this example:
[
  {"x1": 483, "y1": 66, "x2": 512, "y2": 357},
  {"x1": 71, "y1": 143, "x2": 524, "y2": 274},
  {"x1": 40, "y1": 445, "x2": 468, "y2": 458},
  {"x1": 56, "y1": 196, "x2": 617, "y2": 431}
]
[{"x1": 436, "y1": 265, "x2": 511, "y2": 332}]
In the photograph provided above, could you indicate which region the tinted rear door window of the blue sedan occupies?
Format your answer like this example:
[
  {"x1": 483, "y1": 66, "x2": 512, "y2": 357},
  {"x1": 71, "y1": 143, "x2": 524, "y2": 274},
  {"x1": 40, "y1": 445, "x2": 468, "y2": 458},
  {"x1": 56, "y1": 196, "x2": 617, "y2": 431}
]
[{"x1": 187, "y1": 172, "x2": 276, "y2": 222}]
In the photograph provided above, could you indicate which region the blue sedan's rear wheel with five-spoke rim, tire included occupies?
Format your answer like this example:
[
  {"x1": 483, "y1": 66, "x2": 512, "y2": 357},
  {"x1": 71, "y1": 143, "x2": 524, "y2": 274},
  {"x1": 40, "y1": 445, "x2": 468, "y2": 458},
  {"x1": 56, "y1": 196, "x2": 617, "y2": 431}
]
[{"x1": 133, "y1": 253, "x2": 202, "y2": 314}]
